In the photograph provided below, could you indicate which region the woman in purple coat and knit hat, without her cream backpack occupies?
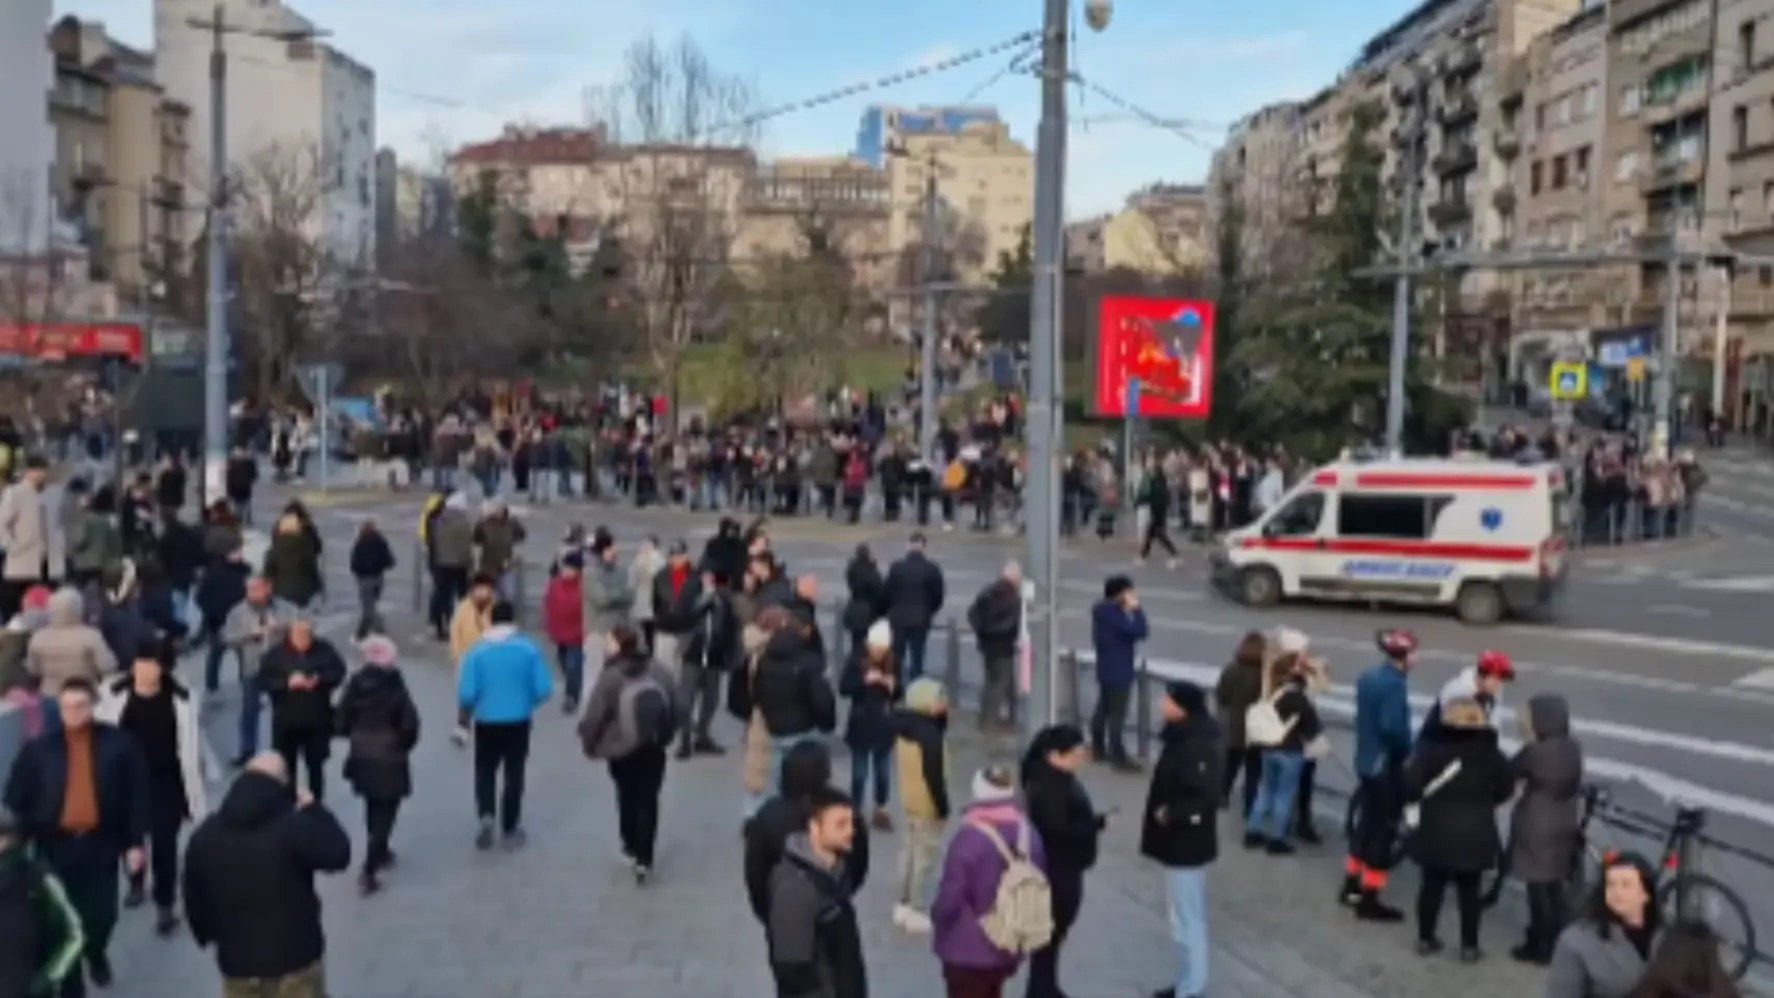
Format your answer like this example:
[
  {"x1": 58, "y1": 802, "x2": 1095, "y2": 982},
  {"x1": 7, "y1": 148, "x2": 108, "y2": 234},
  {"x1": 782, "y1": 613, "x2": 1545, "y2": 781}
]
[{"x1": 930, "y1": 766, "x2": 1047, "y2": 998}]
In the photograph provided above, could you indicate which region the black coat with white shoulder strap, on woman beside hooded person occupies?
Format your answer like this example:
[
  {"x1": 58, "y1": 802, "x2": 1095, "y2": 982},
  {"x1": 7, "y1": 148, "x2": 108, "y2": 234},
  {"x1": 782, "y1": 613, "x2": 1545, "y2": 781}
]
[{"x1": 1405, "y1": 725, "x2": 1515, "y2": 874}]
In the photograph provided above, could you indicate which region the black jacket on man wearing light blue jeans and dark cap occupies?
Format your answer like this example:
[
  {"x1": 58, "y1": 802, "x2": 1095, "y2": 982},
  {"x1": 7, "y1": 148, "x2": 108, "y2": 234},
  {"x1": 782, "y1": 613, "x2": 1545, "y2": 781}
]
[{"x1": 1139, "y1": 714, "x2": 1226, "y2": 869}]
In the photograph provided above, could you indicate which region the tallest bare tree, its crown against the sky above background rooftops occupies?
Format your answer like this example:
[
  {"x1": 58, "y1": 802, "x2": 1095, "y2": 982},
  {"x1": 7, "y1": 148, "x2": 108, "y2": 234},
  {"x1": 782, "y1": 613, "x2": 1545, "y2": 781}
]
[{"x1": 605, "y1": 35, "x2": 757, "y2": 421}]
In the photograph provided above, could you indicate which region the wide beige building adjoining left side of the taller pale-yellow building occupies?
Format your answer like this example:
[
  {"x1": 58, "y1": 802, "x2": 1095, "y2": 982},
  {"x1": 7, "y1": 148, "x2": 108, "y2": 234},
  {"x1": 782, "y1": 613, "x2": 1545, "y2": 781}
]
[{"x1": 733, "y1": 156, "x2": 896, "y2": 289}]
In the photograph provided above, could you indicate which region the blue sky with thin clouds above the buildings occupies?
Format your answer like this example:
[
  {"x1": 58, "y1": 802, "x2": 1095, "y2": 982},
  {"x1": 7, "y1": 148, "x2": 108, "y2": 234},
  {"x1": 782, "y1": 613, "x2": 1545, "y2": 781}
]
[{"x1": 55, "y1": 0, "x2": 1414, "y2": 216}]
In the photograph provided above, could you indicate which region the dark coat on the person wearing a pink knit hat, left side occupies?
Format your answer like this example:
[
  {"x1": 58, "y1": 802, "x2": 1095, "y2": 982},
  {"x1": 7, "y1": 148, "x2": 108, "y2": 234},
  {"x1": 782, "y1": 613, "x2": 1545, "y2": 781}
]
[{"x1": 337, "y1": 665, "x2": 419, "y2": 801}]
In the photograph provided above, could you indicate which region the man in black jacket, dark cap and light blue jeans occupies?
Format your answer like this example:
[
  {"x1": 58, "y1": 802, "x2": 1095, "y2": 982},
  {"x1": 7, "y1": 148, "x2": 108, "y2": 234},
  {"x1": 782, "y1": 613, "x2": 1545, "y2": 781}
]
[{"x1": 1139, "y1": 682, "x2": 1226, "y2": 998}]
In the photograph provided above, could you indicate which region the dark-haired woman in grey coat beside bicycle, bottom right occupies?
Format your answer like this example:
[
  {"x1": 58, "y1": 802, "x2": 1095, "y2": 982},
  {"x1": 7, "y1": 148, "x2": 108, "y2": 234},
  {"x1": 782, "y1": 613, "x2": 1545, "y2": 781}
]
[{"x1": 1547, "y1": 853, "x2": 1659, "y2": 998}]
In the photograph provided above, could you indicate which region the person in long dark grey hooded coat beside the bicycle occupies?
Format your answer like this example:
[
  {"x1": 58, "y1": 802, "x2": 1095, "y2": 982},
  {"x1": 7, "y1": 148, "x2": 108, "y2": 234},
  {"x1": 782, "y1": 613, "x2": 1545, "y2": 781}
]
[{"x1": 1508, "y1": 693, "x2": 1582, "y2": 964}]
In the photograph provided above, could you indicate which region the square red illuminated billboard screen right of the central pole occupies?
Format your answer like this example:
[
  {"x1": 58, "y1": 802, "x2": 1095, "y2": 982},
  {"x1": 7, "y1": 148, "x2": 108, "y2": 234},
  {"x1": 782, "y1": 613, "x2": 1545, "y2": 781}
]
[{"x1": 1089, "y1": 294, "x2": 1213, "y2": 420}]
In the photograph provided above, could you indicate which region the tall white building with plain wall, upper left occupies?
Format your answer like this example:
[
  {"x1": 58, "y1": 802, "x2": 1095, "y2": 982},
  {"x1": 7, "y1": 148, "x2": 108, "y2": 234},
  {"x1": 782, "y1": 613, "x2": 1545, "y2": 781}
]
[{"x1": 154, "y1": 0, "x2": 376, "y2": 268}]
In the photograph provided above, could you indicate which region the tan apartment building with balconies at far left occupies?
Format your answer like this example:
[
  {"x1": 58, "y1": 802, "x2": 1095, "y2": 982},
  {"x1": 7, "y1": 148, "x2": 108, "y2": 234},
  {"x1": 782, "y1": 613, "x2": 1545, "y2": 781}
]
[{"x1": 48, "y1": 18, "x2": 200, "y2": 289}]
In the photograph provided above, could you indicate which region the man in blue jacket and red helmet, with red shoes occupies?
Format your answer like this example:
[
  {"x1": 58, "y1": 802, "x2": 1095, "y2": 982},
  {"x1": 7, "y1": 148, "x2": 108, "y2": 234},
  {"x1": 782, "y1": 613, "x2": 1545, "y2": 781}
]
[{"x1": 1339, "y1": 631, "x2": 1417, "y2": 922}]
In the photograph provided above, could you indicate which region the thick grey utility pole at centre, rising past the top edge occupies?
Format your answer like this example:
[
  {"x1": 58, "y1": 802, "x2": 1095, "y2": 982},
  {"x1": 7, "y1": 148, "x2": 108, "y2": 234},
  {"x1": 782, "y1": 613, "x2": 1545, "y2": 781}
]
[{"x1": 1022, "y1": 0, "x2": 1070, "y2": 736}]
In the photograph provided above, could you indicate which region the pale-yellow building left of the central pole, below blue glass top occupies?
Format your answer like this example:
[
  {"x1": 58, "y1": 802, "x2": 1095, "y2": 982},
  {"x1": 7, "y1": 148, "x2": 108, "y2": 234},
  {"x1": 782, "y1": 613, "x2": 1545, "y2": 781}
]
[{"x1": 887, "y1": 121, "x2": 1034, "y2": 280}]
